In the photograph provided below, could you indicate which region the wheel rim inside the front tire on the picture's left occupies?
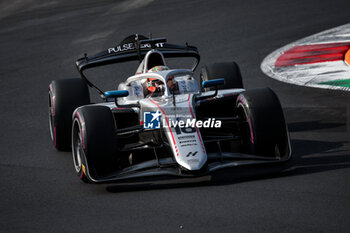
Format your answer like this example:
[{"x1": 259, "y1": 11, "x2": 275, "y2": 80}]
[{"x1": 72, "y1": 120, "x2": 84, "y2": 175}]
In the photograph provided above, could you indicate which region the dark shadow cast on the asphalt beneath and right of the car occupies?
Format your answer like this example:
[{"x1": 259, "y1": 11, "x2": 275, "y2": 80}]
[{"x1": 106, "y1": 137, "x2": 350, "y2": 193}]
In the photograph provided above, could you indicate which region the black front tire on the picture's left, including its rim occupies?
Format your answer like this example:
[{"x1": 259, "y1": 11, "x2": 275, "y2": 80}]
[{"x1": 72, "y1": 105, "x2": 118, "y2": 181}]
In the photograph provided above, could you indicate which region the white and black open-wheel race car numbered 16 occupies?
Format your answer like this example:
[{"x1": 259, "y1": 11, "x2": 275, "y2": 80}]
[{"x1": 49, "y1": 34, "x2": 291, "y2": 183}]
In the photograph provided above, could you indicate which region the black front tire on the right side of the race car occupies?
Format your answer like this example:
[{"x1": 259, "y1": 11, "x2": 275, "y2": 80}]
[{"x1": 236, "y1": 88, "x2": 290, "y2": 158}]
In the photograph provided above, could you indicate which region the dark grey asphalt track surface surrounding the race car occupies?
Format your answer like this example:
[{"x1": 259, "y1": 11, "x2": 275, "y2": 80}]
[{"x1": 0, "y1": 0, "x2": 350, "y2": 232}]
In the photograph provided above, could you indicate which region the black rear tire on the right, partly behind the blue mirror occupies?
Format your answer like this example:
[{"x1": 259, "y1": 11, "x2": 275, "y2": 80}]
[{"x1": 200, "y1": 62, "x2": 243, "y2": 91}]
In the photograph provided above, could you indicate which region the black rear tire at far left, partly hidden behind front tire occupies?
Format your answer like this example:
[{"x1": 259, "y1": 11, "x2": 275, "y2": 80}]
[{"x1": 48, "y1": 78, "x2": 90, "y2": 151}]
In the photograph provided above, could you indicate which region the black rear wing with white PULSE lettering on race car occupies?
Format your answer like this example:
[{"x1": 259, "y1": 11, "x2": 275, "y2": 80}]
[{"x1": 76, "y1": 34, "x2": 200, "y2": 96}]
